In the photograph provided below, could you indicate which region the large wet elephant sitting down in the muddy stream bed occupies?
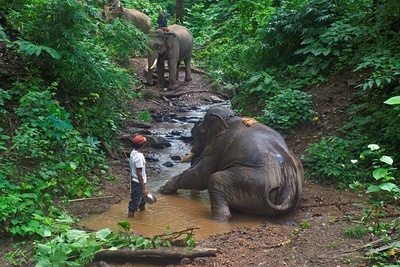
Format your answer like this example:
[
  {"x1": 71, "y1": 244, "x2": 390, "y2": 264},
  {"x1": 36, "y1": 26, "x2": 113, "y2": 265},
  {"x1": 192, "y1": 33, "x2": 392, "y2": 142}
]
[{"x1": 159, "y1": 106, "x2": 304, "y2": 221}]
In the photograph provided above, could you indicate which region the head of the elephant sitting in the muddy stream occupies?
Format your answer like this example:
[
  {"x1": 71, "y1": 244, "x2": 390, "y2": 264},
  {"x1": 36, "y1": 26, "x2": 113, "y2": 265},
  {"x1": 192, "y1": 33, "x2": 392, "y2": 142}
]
[{"x1": 182, "y1": 106, "x2": 236, "y2": 165}]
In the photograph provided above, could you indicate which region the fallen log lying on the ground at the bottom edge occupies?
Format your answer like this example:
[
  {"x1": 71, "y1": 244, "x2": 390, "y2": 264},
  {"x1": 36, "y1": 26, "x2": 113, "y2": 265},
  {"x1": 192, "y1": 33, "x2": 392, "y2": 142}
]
[{"x1": 94, "y1": 247, "x2": 217, "y2": 262}]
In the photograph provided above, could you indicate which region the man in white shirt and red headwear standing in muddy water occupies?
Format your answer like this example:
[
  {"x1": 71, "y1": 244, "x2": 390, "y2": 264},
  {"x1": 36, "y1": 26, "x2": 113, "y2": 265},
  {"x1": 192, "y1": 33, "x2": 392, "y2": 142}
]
[{"x1": 128, "y1": 135, "x2": 148, "y2": 217}]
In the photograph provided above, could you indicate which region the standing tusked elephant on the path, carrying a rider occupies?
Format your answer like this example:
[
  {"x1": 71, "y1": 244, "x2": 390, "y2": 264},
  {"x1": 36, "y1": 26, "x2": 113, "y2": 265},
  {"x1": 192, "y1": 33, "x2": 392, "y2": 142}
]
[{"x1": 147, "y1": 24, "x2": 193, "y2": 89}]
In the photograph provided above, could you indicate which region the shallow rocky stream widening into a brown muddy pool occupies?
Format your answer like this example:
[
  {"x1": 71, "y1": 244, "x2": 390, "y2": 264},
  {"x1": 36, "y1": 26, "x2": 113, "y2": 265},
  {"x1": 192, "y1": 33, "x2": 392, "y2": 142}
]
[{"x1": 81, "y1": 103, "x2": 294, "y2": 240}]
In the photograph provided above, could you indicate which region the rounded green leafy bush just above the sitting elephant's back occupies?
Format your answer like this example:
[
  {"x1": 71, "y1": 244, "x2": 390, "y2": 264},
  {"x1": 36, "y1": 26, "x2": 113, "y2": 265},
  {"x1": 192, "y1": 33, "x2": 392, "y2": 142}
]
[{"x1": 257, "y1": 89, "x2": 314, "y2": 131}]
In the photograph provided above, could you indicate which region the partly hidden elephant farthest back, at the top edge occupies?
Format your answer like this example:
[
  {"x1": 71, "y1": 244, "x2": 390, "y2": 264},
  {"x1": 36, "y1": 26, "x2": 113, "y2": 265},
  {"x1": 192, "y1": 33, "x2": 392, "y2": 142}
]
[{"x1": 104, "y1": 0, "x2": 151, "y2": 34}]
